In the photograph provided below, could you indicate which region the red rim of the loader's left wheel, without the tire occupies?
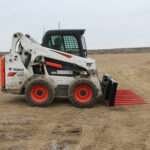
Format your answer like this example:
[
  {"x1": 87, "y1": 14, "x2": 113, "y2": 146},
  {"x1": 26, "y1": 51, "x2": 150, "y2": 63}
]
[{"x1": 31, "y1": 85, "x2": 48, "y2": 103}]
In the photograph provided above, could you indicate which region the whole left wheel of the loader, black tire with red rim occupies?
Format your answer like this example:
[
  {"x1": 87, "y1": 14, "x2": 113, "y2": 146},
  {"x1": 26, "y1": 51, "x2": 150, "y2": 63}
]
[{"x1": 25, "y1": 77, "x2": 55, "y2": 107}]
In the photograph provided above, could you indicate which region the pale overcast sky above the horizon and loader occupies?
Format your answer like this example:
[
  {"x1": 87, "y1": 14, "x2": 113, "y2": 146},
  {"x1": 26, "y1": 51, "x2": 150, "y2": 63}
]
[{"x1": 0, "y1": 0, "x2": 150, "y2": 51}]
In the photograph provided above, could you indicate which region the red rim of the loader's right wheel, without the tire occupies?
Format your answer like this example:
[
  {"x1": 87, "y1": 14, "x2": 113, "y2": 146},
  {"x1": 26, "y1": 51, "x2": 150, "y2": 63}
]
[{"x1": 74, "y1": 84, "x2": 93, "y2": 103}]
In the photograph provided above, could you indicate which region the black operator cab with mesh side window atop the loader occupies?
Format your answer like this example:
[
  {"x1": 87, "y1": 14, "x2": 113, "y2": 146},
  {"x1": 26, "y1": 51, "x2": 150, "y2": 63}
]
[{"x1": 42, "y1": 30, "x2": 87, "y2": 57}]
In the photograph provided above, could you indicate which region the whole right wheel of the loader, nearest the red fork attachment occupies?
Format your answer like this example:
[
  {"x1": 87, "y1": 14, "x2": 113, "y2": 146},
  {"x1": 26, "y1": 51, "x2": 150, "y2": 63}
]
[{"x1": 68, "y1": 79, "x2": 98, "y2": 108}]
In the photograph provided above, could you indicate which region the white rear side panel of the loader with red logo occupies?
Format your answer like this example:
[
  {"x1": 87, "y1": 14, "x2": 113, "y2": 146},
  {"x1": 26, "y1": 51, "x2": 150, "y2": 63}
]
[{"x1": 5, "y1": 53, "x2": 30, "y2": 92}]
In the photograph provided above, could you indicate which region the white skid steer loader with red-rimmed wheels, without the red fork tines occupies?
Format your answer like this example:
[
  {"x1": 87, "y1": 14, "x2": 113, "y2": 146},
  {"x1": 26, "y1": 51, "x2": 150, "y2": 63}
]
[{"x1": 0, "y1": 30, "x2": 118, "y2": 107}]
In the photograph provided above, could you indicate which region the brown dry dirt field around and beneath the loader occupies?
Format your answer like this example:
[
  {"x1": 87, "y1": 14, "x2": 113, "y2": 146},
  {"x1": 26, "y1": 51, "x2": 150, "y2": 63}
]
[{"x1": 0, "y1": 53, "x2": 150, "y2": 150}]
